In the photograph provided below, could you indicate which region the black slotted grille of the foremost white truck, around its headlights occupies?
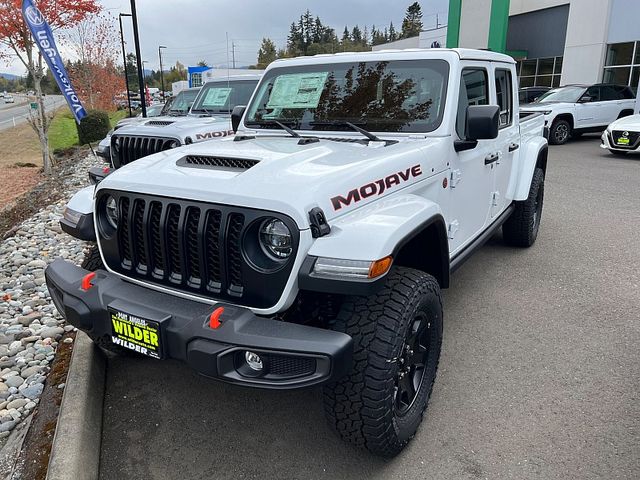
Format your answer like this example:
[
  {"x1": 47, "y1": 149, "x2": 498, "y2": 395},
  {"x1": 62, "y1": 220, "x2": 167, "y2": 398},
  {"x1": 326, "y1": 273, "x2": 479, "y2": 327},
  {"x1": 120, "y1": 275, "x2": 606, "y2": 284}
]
[{"x1": 96, "y1": 190, "x2": 298, "y2": 307}]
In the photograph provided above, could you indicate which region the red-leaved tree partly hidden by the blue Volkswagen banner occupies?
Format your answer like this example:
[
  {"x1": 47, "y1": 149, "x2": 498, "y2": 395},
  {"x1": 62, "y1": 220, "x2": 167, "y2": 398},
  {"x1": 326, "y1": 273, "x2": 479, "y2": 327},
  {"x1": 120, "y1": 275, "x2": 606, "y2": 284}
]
[{"x1": 0, "y1": 0, "x2": 102, "y2": 174}]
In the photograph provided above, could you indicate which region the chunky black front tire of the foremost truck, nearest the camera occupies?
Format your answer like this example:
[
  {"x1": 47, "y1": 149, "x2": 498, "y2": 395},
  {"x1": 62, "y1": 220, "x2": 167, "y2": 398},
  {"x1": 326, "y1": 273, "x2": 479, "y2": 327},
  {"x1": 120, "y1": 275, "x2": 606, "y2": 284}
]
[{"x1": 324, "y1": 267, "x2": 442, "y2": 457}]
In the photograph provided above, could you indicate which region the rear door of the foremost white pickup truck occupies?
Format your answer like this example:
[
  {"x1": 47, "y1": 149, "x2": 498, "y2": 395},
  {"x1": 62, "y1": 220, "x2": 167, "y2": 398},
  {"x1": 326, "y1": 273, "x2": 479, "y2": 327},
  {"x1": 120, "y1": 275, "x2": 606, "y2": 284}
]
[{"x1": 491, "y1": 63, "x2": 520, "y2": 218}]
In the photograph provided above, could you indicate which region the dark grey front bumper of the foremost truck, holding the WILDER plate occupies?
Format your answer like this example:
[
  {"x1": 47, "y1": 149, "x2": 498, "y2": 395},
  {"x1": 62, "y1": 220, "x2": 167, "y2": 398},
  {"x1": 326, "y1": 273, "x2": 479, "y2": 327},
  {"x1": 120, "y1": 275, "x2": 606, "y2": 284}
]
[{"x1": 45, "y1": 260, "x2": 353, "y2": 389}]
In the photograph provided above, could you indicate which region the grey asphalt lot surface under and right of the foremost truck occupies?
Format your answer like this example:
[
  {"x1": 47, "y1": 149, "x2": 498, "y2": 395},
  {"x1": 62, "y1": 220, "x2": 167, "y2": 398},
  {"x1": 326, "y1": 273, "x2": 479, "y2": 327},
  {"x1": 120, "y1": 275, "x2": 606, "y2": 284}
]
[{"x1": 100, "y1": 136, "x2": 640, "y2": 480}]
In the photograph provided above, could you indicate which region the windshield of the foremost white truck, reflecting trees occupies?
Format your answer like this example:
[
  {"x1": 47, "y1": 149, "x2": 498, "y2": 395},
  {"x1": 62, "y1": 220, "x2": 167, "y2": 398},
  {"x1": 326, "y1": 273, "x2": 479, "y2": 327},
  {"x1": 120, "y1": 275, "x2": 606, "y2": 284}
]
[{"x1": 245, "y1": 60, "x2": 449, "y2": 132}]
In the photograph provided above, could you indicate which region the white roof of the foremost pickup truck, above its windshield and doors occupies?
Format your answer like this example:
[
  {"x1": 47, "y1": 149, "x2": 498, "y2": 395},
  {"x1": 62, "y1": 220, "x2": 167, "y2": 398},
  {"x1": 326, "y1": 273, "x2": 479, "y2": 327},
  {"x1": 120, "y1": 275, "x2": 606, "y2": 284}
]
[{"x1": 269, "y1": 48, "x2": 516, "y2": 69}]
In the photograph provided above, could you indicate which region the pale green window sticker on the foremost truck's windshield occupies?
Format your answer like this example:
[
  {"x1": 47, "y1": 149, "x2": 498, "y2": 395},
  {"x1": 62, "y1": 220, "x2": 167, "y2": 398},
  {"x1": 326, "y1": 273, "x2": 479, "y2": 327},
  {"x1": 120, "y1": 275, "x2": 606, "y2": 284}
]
[{"x1": 267, "y1": 72, "x2": 329, "y2": 108}]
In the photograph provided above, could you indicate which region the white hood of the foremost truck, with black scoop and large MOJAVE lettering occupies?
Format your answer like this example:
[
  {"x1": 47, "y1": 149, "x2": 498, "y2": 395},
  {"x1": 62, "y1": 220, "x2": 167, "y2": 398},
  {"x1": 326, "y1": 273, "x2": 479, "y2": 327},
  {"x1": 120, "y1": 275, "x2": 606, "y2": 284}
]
[{"x1": 99, "y1": 136, "x2": 450, "y2": 228}]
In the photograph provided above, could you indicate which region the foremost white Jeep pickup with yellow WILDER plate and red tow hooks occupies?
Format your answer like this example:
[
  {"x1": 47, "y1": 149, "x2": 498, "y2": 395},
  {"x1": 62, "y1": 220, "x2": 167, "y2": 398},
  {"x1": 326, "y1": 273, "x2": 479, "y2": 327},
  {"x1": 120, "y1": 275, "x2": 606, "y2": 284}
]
[{"x1": 46, "y1": 49, "x2": 547, "y2": 456}]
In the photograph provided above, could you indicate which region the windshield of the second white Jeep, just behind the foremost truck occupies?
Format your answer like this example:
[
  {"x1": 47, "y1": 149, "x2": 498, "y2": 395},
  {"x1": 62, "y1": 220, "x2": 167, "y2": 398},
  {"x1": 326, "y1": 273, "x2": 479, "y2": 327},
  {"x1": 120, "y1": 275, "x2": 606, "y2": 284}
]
[{"x1": 191, "y1": 79, "x2": 258, "y2": 114}]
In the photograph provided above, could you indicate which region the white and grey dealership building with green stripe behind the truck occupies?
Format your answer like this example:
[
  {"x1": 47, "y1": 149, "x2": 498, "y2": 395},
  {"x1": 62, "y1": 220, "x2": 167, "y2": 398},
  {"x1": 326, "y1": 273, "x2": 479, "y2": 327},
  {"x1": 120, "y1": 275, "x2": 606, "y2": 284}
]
[{"x1": 374, "y1": 0, "x2": 640, "y2": 89}]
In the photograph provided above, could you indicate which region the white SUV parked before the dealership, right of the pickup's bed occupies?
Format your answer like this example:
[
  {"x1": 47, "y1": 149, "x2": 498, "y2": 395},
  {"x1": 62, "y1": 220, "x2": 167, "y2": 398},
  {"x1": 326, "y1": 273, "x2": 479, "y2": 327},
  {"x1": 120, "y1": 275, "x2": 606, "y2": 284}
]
[{"x1": 522, "y1": 83, "x2": 635, "y2": 145}]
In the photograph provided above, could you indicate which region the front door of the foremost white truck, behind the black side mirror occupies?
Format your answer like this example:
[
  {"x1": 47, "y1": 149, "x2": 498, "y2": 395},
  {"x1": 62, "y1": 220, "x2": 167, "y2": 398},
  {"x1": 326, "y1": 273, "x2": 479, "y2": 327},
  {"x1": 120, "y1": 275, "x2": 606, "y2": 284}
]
[{"x1": 447, "y1": 65, "x2": 496, "y2": 255}]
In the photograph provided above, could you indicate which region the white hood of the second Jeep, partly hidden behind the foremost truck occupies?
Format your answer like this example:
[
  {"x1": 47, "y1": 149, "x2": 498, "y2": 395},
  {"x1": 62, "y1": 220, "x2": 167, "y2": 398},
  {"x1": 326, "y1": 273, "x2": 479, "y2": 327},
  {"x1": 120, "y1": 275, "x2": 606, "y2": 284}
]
[{"x1": 115, "y1": 116, "x2": 233, "y2": 144}]
